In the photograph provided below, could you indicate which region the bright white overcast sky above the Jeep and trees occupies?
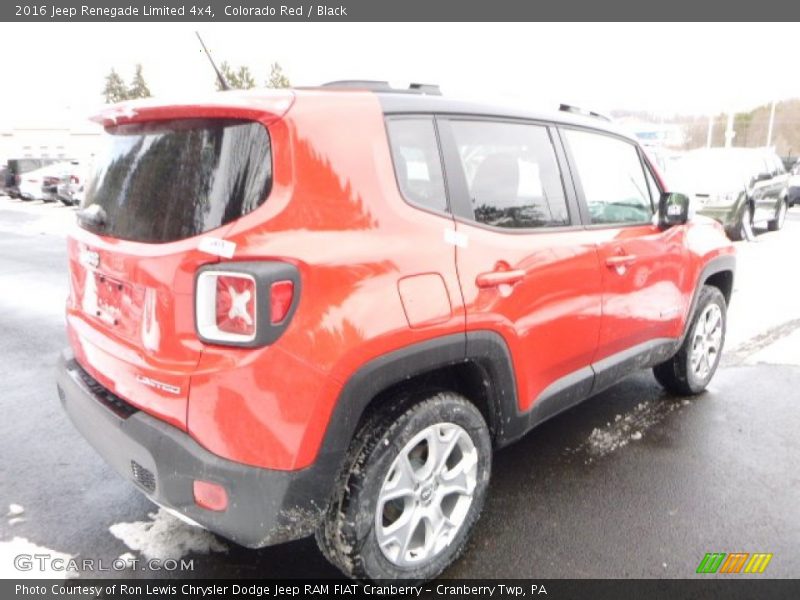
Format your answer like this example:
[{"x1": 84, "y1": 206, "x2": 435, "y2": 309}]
[{"x1": 0, "y1": 23, "x2": 800, "y2": 126}]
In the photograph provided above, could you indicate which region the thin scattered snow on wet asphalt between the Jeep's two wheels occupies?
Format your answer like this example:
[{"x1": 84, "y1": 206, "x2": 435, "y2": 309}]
[{"x1": 575, "y1": 400, "x2": 691, "y2": 462}]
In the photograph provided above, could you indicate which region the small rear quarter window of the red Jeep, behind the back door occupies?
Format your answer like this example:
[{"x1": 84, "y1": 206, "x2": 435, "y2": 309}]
[{"x1": 387, "y1": 117, "x2": 447, "y2": 211}]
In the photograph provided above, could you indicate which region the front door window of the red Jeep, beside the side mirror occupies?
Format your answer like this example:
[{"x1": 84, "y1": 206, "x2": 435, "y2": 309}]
[{"x1": 565, "y1": 129, "x2": 653, "y2": 224}]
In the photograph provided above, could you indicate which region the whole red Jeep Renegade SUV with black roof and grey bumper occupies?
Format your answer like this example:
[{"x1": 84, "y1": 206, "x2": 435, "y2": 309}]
[{"x1": 53, "y1": 82, "x2": 735, "y2": 579}]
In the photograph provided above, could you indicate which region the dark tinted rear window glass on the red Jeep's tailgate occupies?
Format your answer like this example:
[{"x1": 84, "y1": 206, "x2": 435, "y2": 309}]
[{"x1": 81, "y1": 119, "x2": 272, "y2": 242}]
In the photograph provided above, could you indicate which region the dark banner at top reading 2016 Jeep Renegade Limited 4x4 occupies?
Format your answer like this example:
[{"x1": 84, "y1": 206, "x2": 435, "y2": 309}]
[{"x1": 0, "y1": 0, "x2": 800, "y2": 22}]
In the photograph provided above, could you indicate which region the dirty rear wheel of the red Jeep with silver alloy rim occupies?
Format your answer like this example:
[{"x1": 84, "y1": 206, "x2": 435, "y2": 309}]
[{"x1": 317, "y1": 392, "x2": 492, "y2": 581}]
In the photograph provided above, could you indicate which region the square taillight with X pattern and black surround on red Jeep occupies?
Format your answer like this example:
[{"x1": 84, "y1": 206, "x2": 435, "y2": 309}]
[{"x1": 195, "y1": 261, "x2": 300, "y2": 347}]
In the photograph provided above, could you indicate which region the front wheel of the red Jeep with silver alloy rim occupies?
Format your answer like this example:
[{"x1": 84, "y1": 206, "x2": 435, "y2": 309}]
[{"x1": 653, "y1": 285, "x2": 727, "y2": 396}]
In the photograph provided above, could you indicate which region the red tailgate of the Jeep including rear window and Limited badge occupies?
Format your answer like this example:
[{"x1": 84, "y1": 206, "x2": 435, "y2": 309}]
[{"x1": 67, "y1": 94, "x2": 290, "y2": 430}]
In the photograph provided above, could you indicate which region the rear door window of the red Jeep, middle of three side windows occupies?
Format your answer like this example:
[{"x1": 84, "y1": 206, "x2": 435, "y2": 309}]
[{"x1": 451, "y1": 120, "x2": 569, "y2": 228}]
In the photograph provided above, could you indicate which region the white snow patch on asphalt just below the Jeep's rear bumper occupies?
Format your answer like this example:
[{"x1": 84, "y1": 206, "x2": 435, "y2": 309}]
[{"x1": 108, "y1": 508, "x2": 228, "y2": 560}]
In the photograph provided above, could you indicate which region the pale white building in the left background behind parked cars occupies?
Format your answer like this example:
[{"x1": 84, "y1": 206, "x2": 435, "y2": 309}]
[{"x1": 0, "y1": 111, "x2": 103, "y2": 164}]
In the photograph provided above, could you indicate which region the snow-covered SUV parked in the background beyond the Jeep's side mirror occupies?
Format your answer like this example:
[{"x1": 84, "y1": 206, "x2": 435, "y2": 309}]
[{"x1": 668, "y1": 148, "x2": 789, "y2": 240}]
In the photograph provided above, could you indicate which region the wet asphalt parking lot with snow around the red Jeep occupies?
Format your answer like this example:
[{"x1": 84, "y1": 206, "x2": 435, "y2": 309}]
[{"x1": 0, "y1": 196, "x2": 800, "y2": 578}]
